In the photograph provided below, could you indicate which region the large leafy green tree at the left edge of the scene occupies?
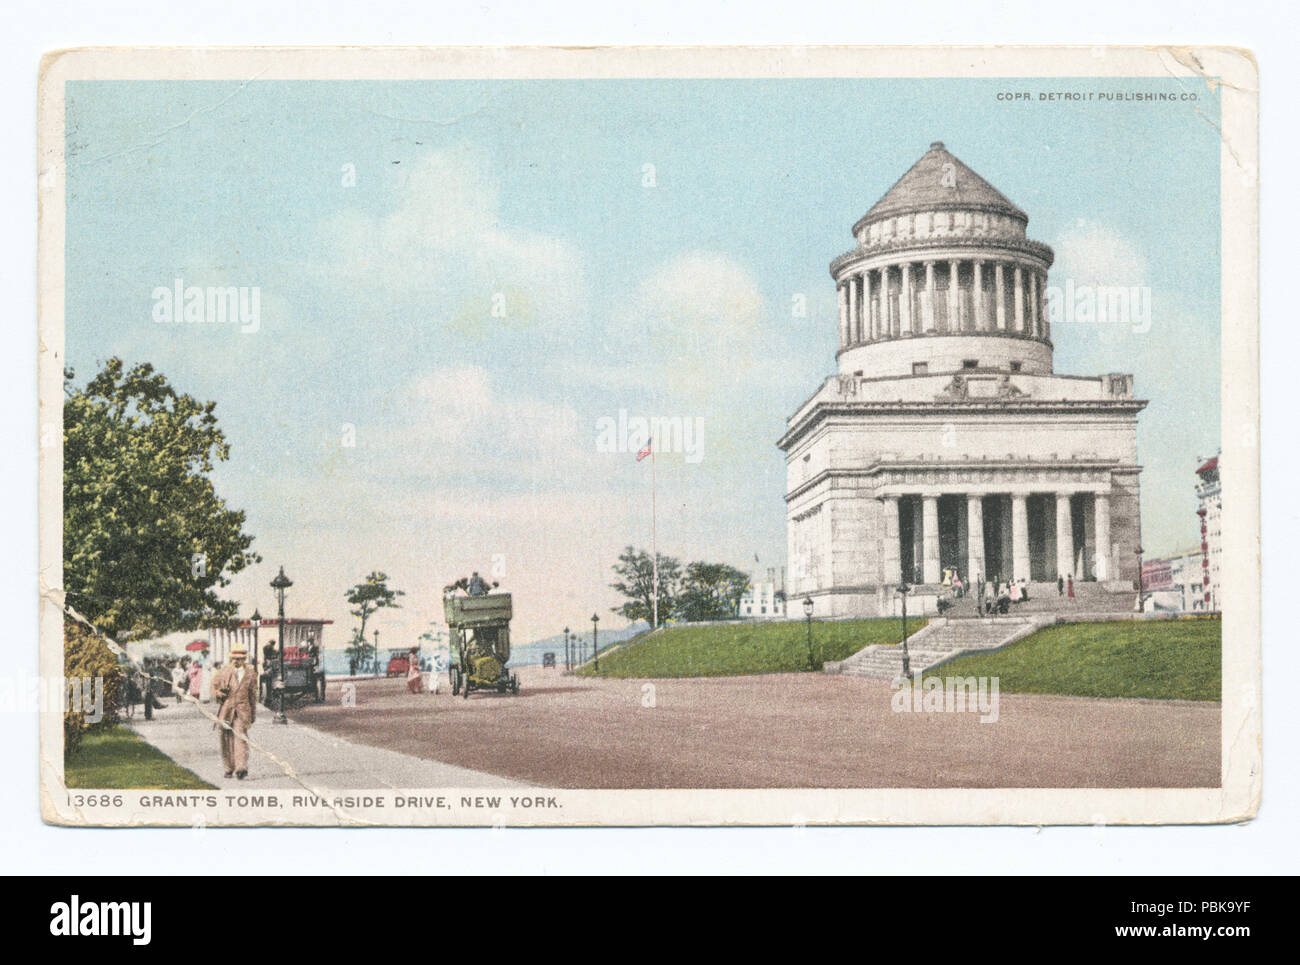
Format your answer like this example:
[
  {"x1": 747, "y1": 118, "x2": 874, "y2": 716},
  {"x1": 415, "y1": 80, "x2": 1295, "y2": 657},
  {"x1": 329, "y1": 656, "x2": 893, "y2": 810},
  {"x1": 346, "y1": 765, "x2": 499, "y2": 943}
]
[{"x1": 64, "y1": 358, "x2": 261, "y2": 640}]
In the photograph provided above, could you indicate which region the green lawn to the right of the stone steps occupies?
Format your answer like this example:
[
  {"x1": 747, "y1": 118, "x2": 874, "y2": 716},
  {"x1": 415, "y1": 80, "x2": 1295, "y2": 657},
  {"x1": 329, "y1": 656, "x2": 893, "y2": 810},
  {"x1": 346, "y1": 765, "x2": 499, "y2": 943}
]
[{"x1": 927, "y1": 616, "x2": 1222, "y2": 700}]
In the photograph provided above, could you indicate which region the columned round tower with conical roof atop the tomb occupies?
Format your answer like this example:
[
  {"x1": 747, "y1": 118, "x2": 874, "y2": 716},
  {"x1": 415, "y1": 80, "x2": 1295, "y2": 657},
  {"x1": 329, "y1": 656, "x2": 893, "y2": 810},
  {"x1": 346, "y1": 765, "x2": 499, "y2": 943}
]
[{"x1": 831, "y1": 140, "x2": 1054, "y2": 378}]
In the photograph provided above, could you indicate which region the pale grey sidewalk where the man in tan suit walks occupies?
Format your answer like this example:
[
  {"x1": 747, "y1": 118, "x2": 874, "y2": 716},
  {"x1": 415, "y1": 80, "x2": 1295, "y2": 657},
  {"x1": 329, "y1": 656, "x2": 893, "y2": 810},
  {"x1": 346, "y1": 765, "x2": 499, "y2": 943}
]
[{"x1": 126, "y1": 700, "x2": 528, "y2": 791}]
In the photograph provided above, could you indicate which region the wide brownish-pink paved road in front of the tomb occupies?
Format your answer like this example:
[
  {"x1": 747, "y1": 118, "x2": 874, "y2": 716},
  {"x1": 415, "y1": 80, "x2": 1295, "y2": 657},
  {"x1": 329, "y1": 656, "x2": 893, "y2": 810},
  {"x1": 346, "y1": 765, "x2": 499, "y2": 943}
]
[{"x1": 289, "y1": 667, "x2": 1221, "y2": 788}]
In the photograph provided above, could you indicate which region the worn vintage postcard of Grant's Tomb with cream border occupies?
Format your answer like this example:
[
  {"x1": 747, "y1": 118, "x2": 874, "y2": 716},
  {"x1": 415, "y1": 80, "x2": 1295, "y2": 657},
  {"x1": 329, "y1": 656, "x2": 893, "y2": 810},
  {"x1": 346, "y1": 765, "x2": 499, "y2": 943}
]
[{"x1": 38, "y1": 47, "x2": 1262, "y2": 827}]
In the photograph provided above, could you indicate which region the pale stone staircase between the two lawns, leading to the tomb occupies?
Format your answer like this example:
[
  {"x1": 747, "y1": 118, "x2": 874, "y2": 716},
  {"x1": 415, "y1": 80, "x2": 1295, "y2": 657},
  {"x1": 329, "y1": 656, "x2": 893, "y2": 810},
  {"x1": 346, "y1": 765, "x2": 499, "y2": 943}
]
[{"x1": 826, "y1": 616, "x2": 1050, "y2": 680}]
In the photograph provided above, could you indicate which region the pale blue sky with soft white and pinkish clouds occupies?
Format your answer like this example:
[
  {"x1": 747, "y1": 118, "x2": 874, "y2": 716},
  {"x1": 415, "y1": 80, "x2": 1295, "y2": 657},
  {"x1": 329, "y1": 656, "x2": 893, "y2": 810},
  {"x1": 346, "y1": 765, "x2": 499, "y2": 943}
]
[{"x1": 65, "y1": 78, "x2": 1221, "y2": 648}]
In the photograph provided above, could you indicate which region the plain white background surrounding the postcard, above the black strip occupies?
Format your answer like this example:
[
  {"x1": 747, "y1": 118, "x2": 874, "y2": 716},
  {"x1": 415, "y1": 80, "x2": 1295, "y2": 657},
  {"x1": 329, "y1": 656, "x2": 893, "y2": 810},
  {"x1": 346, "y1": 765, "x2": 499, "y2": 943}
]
[{"x1": 0, "y1": 0, "x2": 1300, "y2": 875}]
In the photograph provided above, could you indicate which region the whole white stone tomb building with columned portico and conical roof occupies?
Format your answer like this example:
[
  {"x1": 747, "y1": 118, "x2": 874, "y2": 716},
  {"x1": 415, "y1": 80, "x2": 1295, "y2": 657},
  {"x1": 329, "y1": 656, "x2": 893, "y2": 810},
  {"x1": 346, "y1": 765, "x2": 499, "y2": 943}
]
[{"x1": 777, "y1": 143, "x2": 1147, "y2": 616}]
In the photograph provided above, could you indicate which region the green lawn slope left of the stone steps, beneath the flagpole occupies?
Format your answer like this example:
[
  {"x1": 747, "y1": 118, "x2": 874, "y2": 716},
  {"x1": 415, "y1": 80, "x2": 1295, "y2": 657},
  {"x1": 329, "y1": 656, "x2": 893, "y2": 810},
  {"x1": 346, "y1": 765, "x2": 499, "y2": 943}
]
[{"x1": 577, "y1": 618, "x2": 926, "y2": 678}]
